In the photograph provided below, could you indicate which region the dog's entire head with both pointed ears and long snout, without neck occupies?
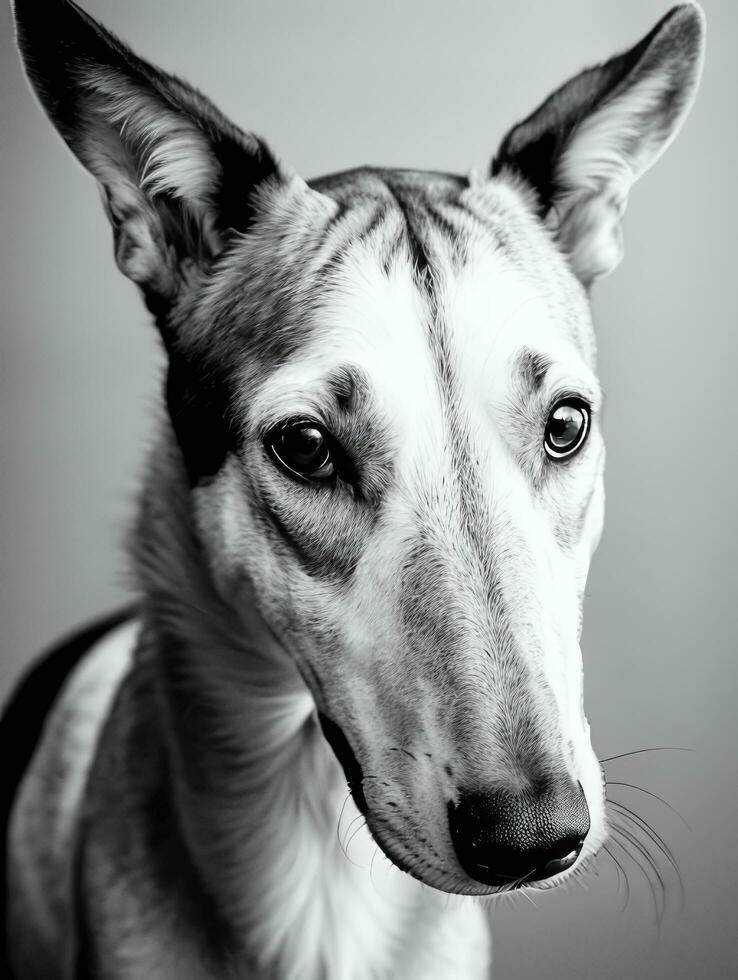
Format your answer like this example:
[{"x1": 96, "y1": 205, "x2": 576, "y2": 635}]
[{"x1": 16, "y1": 0, "x2": 703, "y2": 894}]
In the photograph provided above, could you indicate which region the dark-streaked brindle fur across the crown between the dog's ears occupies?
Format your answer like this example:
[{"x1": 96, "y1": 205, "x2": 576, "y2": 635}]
[{"x1": 193, "y1": 168, "x2": 573, "y2": 368}]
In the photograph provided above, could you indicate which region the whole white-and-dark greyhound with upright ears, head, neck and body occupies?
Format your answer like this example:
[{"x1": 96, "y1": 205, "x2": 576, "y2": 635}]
[{"x1": 3, "y1": 0, "x2": 704, "y2": 980}]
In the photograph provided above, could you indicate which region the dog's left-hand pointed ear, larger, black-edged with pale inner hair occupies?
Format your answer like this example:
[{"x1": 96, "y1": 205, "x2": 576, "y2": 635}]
[{"x1": 14, "y1": 0, "x2": 284, "y2": 310}]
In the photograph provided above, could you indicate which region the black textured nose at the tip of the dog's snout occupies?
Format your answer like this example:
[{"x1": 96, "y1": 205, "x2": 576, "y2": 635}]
[{"x1": 449, "y1": 783, "x2": 589, "y2": 885}]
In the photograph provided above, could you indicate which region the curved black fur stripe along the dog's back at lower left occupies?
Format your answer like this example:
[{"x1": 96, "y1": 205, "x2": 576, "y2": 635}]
[{"x1": 0, "y1": 609, "x2": 135, "y2": 980}]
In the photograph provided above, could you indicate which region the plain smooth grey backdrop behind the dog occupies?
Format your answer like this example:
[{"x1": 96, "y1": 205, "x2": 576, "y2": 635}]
[{"x1": 0, "y1": 0, "x2": 738, "y2": 980}]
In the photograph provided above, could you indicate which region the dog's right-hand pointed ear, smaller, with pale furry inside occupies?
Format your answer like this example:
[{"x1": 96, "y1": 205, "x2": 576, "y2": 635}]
[{"x1": 492, "y1": 3, "x2": 705, "y2": 286}]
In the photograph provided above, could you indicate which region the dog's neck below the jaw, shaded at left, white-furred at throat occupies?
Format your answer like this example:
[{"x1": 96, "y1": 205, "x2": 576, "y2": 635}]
[{"x1": 134, "y1": 442, "x2": 444, "y2": 980}]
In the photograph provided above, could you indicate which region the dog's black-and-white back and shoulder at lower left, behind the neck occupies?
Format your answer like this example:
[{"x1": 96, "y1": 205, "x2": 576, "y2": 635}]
[{"x1": 5, "y1": 612, "x2": 138, "y2": 977}]
